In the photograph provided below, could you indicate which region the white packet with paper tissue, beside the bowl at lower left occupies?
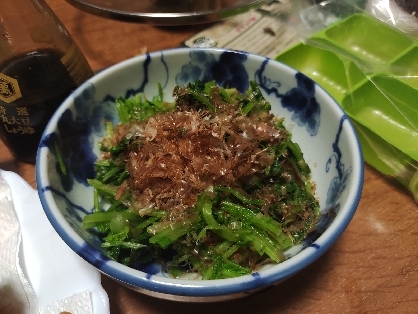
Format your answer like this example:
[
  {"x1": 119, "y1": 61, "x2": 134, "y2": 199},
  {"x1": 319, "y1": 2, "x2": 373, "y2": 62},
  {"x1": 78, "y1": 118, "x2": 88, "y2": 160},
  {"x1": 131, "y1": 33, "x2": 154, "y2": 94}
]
[{"x1": 0, "y1": 170, "x2": 109, "y2": 314}]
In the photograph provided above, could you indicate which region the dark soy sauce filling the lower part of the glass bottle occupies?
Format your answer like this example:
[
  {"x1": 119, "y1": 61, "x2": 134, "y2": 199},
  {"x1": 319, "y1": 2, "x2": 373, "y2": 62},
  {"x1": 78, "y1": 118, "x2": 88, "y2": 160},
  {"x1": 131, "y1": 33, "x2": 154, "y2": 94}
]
[{"x1": 0, "y1": 49, "x2": 77, "y2": 163}]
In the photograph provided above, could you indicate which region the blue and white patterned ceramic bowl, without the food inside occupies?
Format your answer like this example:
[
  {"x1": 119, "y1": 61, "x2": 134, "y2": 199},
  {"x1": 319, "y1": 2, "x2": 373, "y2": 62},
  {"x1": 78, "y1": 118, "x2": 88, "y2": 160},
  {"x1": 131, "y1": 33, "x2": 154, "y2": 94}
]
[{"x1": 36, "y1": 48, "x2": 363, "y2": 301}]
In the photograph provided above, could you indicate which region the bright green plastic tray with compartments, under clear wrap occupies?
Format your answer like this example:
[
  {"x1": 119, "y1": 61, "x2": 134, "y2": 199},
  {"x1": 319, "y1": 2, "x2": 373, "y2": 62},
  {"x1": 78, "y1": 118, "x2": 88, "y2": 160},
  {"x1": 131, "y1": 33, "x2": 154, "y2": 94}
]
[{"x1": 276, "y1": 11, "x2": 418, "y2": 200}]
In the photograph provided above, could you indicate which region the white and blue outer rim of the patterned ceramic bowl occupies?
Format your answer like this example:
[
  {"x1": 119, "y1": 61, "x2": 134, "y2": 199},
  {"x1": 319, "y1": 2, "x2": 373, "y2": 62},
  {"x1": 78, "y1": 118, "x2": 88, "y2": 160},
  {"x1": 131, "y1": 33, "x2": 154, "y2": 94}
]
[{"x1": 36, "y1": 48, "x2": 364, "y2": 297}]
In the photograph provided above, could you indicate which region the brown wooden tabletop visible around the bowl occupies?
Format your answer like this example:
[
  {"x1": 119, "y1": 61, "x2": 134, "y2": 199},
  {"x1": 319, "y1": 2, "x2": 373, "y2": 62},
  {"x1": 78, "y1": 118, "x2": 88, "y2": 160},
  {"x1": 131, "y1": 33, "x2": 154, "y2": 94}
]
[{"x1": 0, "y1": 0, "x2": 418, "y2": 314}]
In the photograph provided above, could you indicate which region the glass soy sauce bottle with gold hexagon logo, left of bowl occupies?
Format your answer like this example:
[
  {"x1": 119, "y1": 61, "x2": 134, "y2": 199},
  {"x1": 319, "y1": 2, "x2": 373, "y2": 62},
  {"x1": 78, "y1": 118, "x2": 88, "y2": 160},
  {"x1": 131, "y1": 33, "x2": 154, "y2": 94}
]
[{"x1": 0, "y1": 0, "x2": 93, "y2": 163}]
